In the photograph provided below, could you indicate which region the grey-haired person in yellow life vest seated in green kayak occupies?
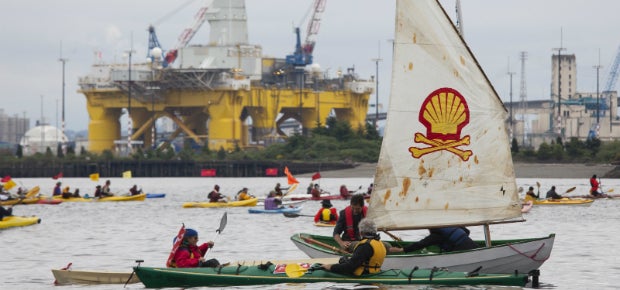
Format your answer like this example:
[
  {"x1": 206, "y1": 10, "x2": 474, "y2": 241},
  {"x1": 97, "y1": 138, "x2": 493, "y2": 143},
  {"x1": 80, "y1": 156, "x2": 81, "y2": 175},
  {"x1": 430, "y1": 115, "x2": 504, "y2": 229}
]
[{"x1": 321, "y1": 218, "x2": 387, "y2": 276}]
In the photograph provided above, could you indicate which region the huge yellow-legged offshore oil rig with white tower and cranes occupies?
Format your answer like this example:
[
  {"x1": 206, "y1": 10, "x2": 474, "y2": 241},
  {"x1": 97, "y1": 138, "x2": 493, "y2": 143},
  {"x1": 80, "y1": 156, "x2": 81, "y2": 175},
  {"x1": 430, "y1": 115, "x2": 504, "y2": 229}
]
[{"x1": 79, "y1": 0, "x2": 375, "y2": 152}]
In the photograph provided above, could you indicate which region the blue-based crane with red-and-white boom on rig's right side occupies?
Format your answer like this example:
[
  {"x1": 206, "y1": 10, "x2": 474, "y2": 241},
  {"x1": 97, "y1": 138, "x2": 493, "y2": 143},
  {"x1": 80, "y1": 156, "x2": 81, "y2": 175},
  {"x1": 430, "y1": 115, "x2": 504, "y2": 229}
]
[{"x1": 286, "y1": 0, "x2": 327, "y2": 66}]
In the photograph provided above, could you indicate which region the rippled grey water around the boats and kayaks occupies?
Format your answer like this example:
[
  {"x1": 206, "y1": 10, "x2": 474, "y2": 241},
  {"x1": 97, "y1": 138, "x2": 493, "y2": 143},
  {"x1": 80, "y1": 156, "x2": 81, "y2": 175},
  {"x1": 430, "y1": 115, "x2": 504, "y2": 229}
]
[{"x1": 0, "y1": 178, "x2": 620, "y2": 289}]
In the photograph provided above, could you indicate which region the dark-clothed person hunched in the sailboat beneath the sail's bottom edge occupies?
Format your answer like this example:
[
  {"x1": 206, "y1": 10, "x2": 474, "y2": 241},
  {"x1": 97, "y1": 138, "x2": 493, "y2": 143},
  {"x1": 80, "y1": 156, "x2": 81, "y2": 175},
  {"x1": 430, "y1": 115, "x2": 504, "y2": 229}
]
[{"x1": 389, "y1": 227, "x2": 478, "y2": 253}]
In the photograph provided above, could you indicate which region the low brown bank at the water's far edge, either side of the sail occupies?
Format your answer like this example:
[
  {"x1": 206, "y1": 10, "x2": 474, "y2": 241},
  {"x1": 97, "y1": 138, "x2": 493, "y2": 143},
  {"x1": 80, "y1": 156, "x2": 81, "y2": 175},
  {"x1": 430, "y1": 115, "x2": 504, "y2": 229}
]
[{"x1": 297, "y1": 162, "x2": 616, "y2": 179}]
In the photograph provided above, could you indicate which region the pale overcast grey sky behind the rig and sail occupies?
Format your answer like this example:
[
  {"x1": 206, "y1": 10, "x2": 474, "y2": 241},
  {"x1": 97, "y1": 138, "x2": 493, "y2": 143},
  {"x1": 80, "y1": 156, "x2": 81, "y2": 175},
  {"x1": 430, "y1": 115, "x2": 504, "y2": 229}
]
[{"x1": 0, "y1": 0, "x2": 620, "y2": 130}]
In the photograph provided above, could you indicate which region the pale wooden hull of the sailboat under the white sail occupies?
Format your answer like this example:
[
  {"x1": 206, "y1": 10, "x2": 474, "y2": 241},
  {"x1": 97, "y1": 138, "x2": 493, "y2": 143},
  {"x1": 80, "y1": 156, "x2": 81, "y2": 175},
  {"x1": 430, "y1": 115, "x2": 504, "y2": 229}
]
[{"x1": 291, "y1": 233, "x2": 555, "y2": 274}]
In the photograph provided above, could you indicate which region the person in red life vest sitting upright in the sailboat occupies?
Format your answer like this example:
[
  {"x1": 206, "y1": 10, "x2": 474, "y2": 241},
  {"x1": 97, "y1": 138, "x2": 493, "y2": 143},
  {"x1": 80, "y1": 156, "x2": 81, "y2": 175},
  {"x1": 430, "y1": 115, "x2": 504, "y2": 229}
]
[{"x1": 333, "y1": 194, "x2": 368, "y2": 252}]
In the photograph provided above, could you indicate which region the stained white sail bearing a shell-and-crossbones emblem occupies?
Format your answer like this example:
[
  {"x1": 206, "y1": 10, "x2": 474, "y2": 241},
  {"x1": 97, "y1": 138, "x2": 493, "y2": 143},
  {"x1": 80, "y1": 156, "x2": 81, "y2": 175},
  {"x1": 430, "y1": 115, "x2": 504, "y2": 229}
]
[{"x1": 368, "y1": 0, "x2": 521, "y2": 230}]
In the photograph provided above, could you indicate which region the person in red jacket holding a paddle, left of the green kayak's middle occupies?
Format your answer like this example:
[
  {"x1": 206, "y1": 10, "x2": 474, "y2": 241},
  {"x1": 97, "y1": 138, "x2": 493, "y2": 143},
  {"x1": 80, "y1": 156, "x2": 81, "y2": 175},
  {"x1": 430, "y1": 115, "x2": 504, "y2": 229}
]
[{"x1": 173, "y1": 229, "x2": 220, "y2": 268}]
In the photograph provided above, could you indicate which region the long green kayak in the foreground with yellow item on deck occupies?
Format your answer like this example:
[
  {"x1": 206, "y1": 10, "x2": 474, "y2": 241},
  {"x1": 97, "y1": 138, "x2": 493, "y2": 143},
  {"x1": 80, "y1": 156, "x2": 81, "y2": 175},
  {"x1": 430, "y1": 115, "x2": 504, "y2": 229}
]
[{"x1": 134, "y1": 263, "x2": 528, "y2": 288}]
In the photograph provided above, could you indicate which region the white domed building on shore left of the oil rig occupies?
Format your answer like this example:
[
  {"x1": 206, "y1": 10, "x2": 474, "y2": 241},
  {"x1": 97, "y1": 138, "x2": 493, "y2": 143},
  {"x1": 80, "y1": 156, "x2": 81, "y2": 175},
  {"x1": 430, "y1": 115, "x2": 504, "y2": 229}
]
[{"x1": 19, "y1": 125, "x2": 68, "y2": 155}]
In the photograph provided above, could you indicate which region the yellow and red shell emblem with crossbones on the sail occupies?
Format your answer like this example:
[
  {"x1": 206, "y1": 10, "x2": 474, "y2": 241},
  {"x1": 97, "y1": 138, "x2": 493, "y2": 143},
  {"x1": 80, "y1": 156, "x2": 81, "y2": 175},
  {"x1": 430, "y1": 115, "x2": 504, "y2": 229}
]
[{"x1": 409, "y1": 88, "x2": 473, "y2": 161}]
